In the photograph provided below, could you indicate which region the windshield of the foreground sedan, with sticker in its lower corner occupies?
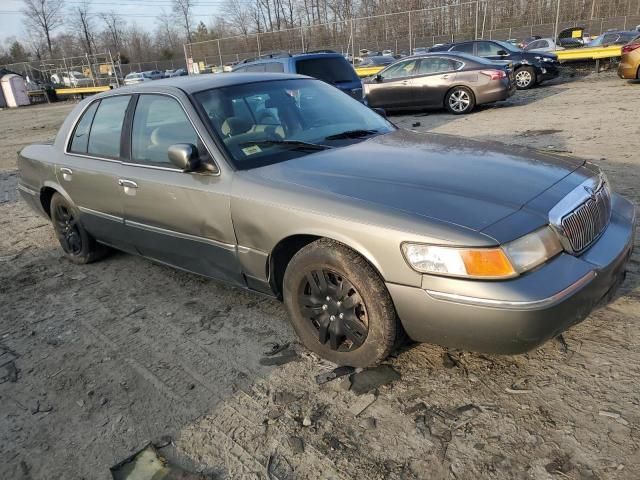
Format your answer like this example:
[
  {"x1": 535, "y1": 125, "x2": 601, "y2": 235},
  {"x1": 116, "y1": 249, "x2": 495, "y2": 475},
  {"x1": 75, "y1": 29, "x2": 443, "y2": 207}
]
[{"x1": 194, "y1": 79, "x2": 395, "y2": 170}]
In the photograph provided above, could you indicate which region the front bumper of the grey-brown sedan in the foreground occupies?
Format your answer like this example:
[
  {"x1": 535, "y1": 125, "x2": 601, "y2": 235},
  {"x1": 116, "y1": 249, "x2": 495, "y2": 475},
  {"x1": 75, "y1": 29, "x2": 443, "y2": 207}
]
[{"x1": 387, "y1": 195, "x2": 635, "y2": 354}]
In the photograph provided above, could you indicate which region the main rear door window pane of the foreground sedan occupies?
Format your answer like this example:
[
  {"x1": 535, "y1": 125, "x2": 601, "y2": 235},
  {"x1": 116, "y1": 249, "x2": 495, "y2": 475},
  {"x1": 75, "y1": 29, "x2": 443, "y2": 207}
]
[{"x1": 87, "y1": 95, "x2": 131, "y2": 158}]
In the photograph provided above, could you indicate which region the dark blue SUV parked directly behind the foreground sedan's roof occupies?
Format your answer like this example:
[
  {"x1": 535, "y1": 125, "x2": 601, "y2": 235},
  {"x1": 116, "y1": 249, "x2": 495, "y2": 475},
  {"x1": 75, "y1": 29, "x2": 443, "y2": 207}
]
[{"x1": 233, "y1": 52, "x2": 362, "y2": 101}]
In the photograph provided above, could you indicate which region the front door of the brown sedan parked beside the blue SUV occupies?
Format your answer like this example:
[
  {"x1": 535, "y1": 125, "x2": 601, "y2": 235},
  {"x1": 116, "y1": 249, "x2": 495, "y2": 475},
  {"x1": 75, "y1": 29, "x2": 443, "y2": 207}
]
[{"x1": 367, "y1": 58, "x2": 419, "y2": 109}]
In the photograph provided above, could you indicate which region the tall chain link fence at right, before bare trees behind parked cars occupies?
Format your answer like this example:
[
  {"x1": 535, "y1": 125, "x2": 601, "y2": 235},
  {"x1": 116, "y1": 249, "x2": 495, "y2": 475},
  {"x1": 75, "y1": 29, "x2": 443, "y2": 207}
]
[{"x1": 184, "y1": 0, "x2": 640, "y2": 73}]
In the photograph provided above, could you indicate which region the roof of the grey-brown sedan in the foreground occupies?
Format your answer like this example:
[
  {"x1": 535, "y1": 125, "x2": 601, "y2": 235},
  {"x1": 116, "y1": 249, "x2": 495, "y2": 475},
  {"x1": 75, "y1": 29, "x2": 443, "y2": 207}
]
[{"x1": 110, "y1": 73, "x2": 309, "y2": 93}]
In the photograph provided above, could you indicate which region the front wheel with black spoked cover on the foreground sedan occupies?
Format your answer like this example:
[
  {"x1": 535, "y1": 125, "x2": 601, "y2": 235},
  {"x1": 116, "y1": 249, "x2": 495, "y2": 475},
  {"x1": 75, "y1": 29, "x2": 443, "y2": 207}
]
[{"x1": 283, "y1": 239, "x2": 401, "y2": 367}]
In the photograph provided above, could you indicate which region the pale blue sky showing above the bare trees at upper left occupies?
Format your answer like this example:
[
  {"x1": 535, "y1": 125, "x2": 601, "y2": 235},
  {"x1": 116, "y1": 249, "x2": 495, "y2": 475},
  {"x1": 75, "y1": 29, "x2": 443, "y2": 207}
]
[{"x1": 0, "y1": 0, "x2": 230, "y2": 43}]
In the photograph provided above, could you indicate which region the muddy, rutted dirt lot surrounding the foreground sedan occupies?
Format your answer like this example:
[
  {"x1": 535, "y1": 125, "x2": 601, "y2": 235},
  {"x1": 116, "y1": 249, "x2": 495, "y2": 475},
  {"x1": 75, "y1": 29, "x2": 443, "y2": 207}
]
[{"x1": 0, "y1": 74, "x2": 640, "y2": 479}]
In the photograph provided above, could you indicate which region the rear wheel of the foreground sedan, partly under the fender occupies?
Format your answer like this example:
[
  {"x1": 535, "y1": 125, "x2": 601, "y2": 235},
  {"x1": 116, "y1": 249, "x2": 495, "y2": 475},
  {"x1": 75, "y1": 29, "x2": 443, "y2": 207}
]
[{"x1": 50, "y1": 193, "x2": 108, "y2": 264}]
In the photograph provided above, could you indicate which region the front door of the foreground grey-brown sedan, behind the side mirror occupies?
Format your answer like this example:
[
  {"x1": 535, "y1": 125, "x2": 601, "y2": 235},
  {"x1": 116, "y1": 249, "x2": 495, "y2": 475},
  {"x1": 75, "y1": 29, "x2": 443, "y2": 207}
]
[{"x1": 119, "y1": 94, "x2": 243, "y2": 284}]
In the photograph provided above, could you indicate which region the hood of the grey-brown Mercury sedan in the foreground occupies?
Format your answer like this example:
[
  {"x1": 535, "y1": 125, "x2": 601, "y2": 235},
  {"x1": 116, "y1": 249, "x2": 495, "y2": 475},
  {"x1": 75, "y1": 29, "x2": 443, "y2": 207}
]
[{"x1": 254, "y1": 130, "x2": 584, "y2": 231}]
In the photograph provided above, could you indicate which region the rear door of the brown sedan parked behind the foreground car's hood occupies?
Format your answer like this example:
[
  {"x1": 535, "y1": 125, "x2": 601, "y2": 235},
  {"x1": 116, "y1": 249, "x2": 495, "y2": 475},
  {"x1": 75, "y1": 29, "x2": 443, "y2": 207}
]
[{"x1": 412, "y1": 57, "x2": 464, "y2": 107}]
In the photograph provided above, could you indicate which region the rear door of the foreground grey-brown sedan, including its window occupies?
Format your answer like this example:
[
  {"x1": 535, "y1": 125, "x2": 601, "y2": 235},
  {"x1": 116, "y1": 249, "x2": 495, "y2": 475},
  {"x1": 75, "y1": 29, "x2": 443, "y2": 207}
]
[{"x1": 56, "y1": 95, "x2": 132, "y2": 250}]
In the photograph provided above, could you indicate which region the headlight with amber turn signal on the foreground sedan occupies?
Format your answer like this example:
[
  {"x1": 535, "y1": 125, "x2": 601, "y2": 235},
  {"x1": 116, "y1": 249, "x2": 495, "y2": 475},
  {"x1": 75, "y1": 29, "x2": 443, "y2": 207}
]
[{"x1": 402, "y1": 227, "x2": 562, "y2": 279}]
